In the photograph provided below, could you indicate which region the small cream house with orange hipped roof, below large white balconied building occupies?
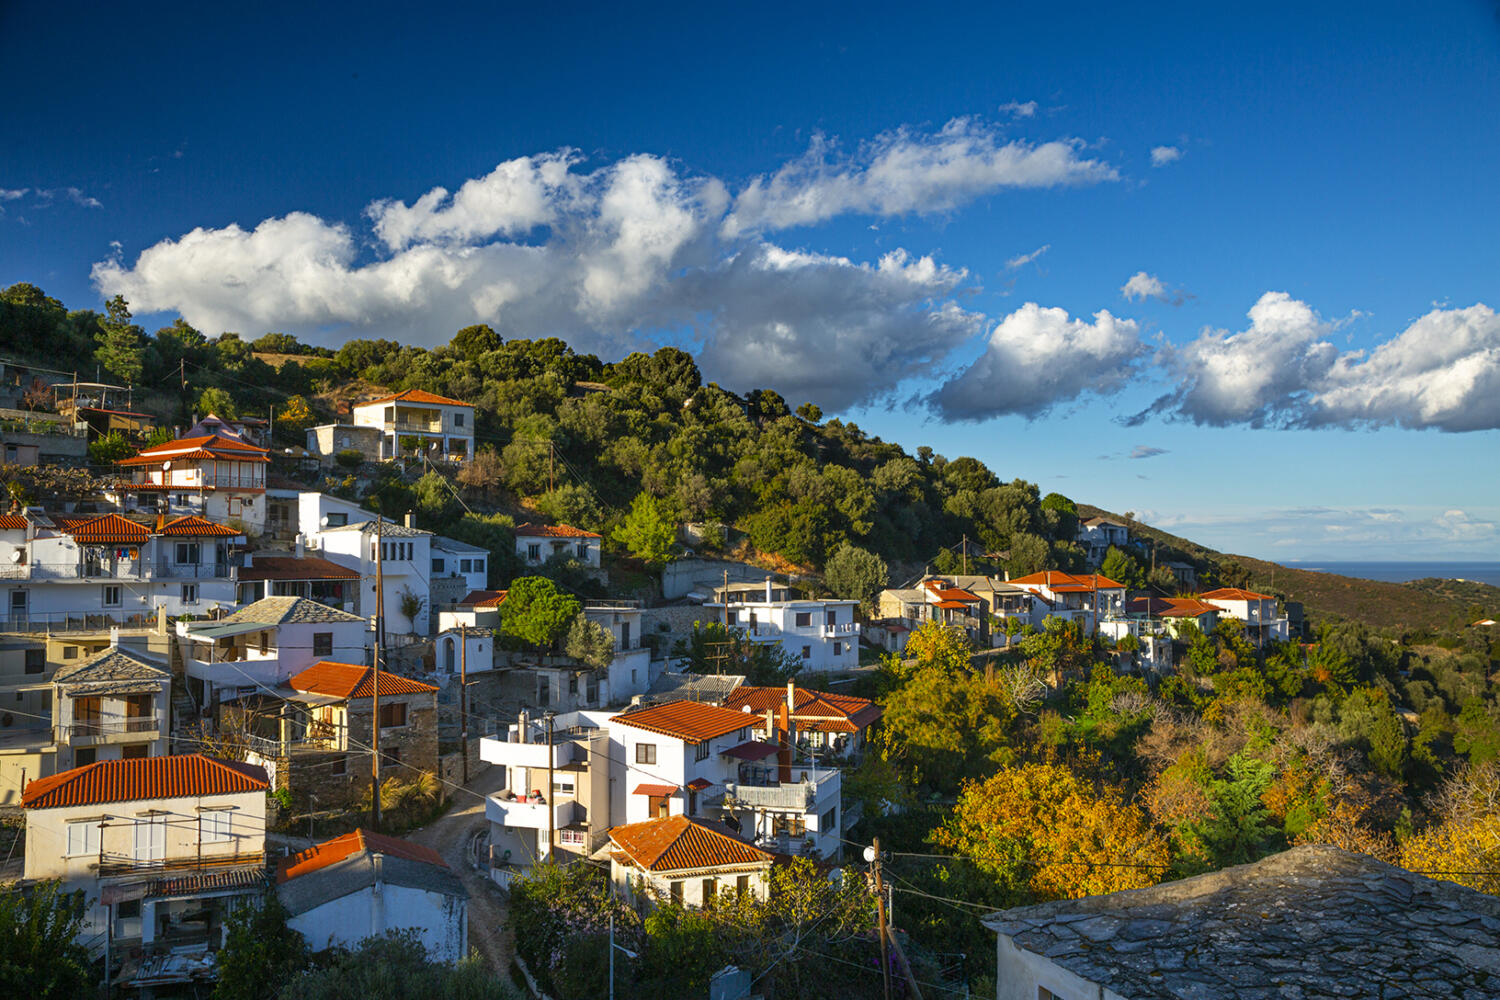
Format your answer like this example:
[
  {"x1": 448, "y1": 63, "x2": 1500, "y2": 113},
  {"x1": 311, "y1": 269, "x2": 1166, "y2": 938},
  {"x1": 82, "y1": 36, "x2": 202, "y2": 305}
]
[{"x1": 609, "y1": 816, "x2": 773, "y2": 909}]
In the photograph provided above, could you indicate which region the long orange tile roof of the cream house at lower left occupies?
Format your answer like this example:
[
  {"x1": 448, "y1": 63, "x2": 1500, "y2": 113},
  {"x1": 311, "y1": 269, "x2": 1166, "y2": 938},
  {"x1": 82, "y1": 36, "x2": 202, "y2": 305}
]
[{"x1": 21, "y1": 754, "x2": 270, "y2": 810}]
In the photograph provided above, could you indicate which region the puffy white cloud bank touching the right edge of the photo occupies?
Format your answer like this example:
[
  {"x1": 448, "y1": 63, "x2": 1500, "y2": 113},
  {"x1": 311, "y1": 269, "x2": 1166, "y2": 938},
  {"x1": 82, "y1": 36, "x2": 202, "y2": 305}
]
[{"x1": 1130, "y1": 292, "x2": 1500, "y2": 432}]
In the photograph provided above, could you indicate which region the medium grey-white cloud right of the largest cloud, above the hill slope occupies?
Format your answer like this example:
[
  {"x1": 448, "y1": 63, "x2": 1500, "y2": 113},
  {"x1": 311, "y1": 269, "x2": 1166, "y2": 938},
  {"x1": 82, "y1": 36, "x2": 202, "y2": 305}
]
[{"x1": 929, "y1": 303, "x2": 1146, "y2": 420}]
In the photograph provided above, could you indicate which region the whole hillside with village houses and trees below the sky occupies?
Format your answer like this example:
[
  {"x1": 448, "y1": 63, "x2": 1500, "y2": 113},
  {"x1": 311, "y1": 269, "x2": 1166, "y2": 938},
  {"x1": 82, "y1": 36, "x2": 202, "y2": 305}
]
[{"x1": 0, "y1": 286, "x2": 1500, "y2": 1000}]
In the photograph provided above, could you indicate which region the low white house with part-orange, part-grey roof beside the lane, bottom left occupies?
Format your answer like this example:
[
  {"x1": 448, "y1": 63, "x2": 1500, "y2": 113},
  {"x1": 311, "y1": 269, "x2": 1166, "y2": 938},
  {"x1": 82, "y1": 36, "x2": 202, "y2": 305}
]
[{"x1": 276, "y1": 829, "x2": 468, "y2": 963}]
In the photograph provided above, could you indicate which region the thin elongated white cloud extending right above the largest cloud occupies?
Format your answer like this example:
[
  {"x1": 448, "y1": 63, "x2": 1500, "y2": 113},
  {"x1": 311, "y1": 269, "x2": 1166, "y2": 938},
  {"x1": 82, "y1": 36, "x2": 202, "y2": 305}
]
[{"x1": 725, "y1": 118, "x2": 1118, "y2": 237}]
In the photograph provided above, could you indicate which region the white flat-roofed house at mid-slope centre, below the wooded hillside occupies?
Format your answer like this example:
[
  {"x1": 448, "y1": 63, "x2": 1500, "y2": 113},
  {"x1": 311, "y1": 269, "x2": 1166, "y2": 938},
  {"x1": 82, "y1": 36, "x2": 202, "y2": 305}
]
[{"x1": 704, "y1": 580, "x2": 860, "y2": 675}]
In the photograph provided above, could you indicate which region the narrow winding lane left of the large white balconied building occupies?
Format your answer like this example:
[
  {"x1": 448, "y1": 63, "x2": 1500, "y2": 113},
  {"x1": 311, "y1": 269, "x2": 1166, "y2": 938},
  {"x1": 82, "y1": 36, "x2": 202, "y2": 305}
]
[{"x1": 405, "y1": 768, "x2": 515, "y2": 981}]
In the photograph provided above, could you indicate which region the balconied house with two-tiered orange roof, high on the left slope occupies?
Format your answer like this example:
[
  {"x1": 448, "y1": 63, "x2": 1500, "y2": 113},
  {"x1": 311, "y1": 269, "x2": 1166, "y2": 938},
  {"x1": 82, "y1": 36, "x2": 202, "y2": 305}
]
[{"x1": 119, "y1": 433, "x2": 270, "y2": 535}]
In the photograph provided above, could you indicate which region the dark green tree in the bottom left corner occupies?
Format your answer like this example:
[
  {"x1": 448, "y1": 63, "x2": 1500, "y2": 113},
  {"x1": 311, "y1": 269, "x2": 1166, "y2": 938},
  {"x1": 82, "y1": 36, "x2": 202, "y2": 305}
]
[{"x1": 0, "y1": 882, "x2": 95, "y2": 1000}]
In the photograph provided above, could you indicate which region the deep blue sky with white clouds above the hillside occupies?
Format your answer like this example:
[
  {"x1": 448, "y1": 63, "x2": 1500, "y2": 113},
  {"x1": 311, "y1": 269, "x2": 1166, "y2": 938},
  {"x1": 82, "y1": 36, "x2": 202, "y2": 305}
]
[{"x1": 0, "y1": 0, "x2": 1500, "y2": 559}]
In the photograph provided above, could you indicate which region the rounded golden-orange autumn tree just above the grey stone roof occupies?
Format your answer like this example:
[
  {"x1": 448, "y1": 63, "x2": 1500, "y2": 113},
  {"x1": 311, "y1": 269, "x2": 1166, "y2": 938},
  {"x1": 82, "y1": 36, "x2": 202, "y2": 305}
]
[{"x1": 933, "y1": 763, "x2": 1169, "y2": 900}]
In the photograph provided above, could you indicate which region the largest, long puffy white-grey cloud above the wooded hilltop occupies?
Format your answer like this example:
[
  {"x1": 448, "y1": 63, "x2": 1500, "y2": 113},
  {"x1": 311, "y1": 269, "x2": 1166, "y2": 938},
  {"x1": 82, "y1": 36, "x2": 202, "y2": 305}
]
[{"x1": 93, "y1": 141, "x2": 983, "y2": 409}]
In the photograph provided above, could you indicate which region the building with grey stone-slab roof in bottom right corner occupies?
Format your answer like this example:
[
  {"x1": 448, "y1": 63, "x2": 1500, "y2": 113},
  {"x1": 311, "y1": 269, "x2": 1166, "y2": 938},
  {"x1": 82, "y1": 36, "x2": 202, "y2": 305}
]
[{"x1": 984, "y1": 844, "x2": 1500, "y2": 1000}]
